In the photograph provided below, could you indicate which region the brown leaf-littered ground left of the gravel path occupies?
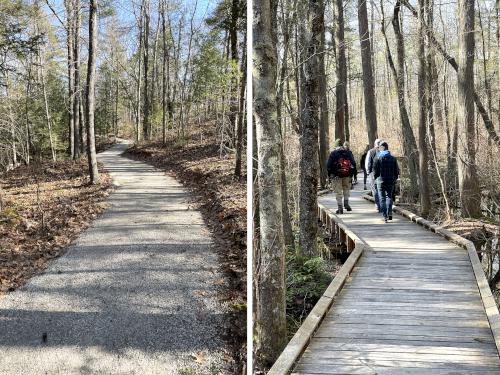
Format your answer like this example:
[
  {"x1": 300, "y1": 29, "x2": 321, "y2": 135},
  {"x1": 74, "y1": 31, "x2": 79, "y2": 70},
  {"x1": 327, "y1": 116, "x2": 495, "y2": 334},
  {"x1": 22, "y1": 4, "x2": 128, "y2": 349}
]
[{"x1": 0, "y1": 158, "x2": 112, "y2": 295}]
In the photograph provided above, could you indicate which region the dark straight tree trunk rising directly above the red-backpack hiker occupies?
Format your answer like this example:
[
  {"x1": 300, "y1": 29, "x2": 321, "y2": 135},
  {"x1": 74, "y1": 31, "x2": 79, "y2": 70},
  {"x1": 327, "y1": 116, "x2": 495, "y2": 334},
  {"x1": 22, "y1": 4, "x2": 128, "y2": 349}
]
[{"x1": 335, "y1": 0, "x2": 349, "y2": 141}]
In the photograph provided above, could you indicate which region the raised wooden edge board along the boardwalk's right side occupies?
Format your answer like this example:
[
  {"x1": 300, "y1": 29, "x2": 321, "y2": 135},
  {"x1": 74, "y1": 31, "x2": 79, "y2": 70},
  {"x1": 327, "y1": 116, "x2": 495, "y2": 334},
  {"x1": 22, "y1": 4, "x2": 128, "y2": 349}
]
[{"x1": 362, "y1": 194, "x2": 500, "y2": 355}]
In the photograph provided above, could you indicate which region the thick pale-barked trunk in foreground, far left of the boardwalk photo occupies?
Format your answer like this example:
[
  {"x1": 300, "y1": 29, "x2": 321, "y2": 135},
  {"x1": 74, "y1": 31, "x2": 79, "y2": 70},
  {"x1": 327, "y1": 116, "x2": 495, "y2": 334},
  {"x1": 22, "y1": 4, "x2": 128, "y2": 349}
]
[{"x1": 253, "y1": 0, "x2": 286, "y2": 368}]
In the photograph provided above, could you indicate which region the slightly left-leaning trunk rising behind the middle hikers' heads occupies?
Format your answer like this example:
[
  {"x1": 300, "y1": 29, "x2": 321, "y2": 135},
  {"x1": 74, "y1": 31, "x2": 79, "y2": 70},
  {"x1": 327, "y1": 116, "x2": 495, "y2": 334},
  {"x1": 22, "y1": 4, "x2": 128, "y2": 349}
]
[{"x1": 358, "y1": 0, "x2": 377, "y2": 145}]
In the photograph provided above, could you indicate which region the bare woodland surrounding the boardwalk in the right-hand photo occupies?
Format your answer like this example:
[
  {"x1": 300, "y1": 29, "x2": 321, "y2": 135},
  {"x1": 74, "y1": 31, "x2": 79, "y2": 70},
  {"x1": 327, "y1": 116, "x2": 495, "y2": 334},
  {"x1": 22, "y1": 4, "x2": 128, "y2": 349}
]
[{"x1": 253, "y1": 0, "x2": 500, "y2": 369}]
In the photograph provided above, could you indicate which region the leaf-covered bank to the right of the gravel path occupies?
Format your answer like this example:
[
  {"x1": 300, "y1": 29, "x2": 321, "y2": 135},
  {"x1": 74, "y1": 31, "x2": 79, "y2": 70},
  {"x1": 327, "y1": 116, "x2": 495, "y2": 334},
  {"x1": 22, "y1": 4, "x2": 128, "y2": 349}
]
[{"x1": 126, "y1": 123, "x2": 247, "y2": 373}]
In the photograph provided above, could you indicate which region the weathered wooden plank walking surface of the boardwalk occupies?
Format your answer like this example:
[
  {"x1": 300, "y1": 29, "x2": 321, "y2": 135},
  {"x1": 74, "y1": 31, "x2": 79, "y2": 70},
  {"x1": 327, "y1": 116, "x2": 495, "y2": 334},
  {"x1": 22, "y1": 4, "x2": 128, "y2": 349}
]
[{"x1": 292, "y1": 190, "x2": 500, "y2": 375}]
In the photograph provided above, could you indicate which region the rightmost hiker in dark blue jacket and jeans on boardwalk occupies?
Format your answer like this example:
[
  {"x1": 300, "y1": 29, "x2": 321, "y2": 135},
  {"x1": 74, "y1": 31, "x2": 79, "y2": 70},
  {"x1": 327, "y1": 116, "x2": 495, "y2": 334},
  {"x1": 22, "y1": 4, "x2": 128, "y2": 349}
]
[{"x1": 373, "y1": 141, "x2": 399, "y2": 223}]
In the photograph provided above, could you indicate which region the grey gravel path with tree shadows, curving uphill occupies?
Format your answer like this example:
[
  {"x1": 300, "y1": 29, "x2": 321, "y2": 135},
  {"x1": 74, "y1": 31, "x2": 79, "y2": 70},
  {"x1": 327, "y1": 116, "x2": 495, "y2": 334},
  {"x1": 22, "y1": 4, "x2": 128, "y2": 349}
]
[{"x1": 0, "y1": 144, "x2": 229, "y2": 375}]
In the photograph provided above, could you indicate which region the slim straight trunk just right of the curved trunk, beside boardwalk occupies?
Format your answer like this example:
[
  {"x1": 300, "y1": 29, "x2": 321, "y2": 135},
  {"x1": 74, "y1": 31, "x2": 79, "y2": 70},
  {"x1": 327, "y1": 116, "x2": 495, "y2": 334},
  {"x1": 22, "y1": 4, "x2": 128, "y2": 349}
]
[{"x1": 417, "y1": 0, "x2": 431, "y2": 217}]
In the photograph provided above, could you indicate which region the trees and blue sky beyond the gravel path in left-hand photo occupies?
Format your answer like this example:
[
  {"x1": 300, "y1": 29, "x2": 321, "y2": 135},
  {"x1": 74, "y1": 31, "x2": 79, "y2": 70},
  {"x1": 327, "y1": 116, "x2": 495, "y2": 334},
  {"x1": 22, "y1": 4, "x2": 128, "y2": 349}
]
[{"x1": 0, "y1": 0, "x2": 246, "y2": 175}]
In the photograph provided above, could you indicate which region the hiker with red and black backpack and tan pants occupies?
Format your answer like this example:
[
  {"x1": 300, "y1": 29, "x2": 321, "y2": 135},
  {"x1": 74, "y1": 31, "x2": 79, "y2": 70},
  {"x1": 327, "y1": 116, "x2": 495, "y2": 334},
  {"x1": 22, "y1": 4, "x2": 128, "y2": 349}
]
[{"x1": 326, "y1": 139, "x2": 357, "y2": 214}]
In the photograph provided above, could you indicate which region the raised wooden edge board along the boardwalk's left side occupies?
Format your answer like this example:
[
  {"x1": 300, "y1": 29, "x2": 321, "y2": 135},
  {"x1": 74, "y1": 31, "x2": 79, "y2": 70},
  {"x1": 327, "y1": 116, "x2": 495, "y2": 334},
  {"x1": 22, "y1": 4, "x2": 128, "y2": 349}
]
[{"x1": 267, "y1": 203, "x2": 368, "y2": 375}]
